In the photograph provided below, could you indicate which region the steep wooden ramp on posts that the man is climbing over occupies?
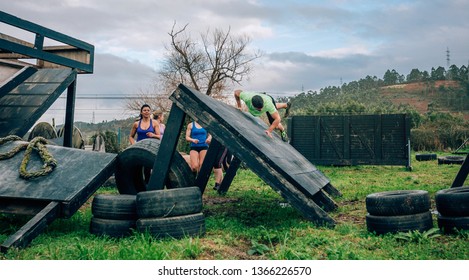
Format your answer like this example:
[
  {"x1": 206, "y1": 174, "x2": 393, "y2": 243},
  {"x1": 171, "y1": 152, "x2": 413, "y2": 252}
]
[{"x1": 149, "y1": 84, "x2": 340, "y2": 226}]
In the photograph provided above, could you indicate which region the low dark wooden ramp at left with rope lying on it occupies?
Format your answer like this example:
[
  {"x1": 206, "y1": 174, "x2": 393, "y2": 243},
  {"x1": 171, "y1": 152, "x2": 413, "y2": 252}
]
[{"x1": 0, "y1": 141, "x2": 116, "y2": 252}]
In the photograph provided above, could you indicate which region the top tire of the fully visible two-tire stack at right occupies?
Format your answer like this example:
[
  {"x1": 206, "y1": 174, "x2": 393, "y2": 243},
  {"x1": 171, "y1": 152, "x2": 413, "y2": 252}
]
[{"x1": 365, "y1": 190, "x2": 430, "y2": 216}]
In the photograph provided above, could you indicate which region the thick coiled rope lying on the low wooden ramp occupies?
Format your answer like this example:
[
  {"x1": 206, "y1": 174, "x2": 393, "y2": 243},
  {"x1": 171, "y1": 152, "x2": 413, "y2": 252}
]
[{"x1": 0, "y1": 135, "x2": 57, "y2": 179}]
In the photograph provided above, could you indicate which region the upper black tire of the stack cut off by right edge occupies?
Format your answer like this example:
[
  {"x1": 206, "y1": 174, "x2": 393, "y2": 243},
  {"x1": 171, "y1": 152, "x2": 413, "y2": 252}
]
[{"x1": 435, "y1": 186, "x2": 469, "y2": 217}]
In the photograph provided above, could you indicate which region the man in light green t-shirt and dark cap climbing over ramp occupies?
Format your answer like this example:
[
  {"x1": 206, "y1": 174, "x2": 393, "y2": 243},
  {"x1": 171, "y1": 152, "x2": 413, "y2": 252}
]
[{"x1": 234, "y1": 90, "x2": 291, "y2": 142}]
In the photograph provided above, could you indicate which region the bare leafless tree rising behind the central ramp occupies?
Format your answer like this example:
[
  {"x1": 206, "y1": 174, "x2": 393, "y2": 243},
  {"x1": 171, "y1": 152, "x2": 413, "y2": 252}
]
[{"x1": 159, "y1": 23, "x2": 261, "y2": 98}]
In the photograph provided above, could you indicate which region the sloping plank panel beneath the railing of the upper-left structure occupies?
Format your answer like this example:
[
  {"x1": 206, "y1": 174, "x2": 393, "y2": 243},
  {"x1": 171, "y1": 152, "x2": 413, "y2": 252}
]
[{"x1": 0, "y1": 69, "x2": 77, "y2": 137}]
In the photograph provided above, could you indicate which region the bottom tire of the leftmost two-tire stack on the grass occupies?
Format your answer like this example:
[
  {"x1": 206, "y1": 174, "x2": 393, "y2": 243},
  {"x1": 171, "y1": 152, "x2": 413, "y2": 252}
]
[{"x1": 90, "y1": 217, "x2": 136, "y2": 237}]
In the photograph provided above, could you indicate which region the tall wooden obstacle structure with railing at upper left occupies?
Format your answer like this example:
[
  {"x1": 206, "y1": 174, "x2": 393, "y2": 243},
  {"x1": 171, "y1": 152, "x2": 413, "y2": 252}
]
[{"x1": 0, "y1": 11, "x2": 94, "y2": 147}]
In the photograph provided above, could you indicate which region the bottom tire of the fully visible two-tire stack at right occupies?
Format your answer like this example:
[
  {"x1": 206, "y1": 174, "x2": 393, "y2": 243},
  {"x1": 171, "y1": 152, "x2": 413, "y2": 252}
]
[{"x1": 366, "y1": 211, "x2": 433, "y2": 234}]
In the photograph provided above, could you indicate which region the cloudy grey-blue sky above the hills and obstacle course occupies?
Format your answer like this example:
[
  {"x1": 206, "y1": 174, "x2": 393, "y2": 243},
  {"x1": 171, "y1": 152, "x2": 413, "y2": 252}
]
[{"x1": 0, "y1": 0, "x2": 469, "y2": 123}]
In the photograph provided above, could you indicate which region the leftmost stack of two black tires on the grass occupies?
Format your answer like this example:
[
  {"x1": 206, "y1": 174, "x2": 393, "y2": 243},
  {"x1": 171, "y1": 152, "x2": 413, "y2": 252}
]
[{"x1": 90, "y1": 194, "x2": 137, "y2": 237}]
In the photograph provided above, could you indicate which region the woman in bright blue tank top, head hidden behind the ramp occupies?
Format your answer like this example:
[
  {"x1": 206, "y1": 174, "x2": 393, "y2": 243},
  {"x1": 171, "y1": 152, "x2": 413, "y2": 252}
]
[{"x1": 186, "y1": 121, "x2": 212, "y2": 172}]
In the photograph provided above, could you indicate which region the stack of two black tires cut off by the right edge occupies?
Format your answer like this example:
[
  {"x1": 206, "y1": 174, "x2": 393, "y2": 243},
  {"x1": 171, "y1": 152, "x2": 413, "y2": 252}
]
[{"x1": 435, "y1": 186, "x2": 469, "y2": 233}]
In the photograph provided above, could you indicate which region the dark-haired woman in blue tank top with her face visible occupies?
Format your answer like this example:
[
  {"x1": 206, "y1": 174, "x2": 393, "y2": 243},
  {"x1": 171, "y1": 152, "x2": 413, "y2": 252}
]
[{"x1": 129, "y1": 104, "x2": 160, "y2": 145}]
